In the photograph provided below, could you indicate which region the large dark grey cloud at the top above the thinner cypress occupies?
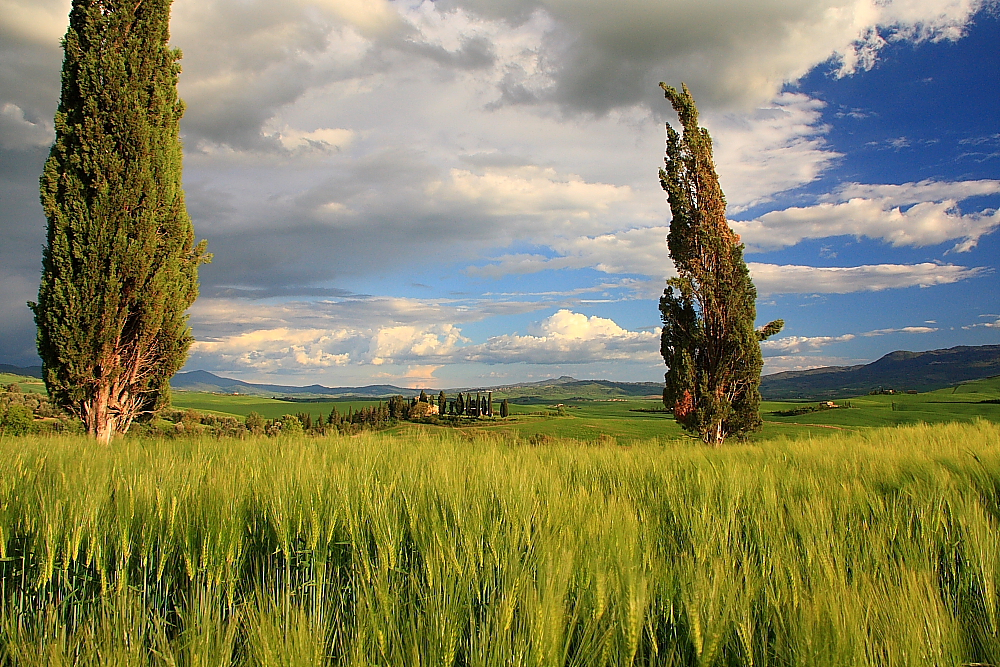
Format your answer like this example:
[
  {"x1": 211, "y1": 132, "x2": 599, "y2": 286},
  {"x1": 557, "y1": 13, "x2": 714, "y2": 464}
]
[{"x1": 446, "y1": 0, "x2": 983, "y2": 115}]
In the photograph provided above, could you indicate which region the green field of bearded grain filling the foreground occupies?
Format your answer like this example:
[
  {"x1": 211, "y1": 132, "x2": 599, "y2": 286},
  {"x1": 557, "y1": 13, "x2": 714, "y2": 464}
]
[{"x1": 0, "y1": 426, "x2": 1000, "y2": 667}]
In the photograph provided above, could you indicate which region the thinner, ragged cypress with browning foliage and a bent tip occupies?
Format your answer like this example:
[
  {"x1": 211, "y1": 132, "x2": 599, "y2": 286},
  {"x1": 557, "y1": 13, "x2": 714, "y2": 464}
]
[{"x1": 660, "y1": 83, "x2": 784, "y2": 445}]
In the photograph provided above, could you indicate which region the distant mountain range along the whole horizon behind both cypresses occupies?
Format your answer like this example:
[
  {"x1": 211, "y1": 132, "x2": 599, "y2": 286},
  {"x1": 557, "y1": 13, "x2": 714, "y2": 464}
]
[{"x1": 7, "y1": 345, "x2": 1000, "y2": 402}]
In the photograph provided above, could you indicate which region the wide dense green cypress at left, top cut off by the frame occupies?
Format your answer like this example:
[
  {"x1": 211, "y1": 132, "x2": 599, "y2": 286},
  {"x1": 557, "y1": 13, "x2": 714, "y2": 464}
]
[{"x1": 31, "y1": 0, "x2": 209, "y2": 442}]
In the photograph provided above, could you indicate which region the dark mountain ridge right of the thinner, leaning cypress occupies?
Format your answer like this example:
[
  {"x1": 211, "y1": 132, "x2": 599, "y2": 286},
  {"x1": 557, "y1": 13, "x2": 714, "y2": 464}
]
[{"x1": 760, "y1": 345, "x2": 1000, "y2": 400}]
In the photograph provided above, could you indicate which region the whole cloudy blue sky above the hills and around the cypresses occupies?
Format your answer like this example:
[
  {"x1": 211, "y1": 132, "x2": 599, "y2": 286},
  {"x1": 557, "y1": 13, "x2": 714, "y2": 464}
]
[{"x1": 0, "y1": 0, "x2": 1000, "y2": 387}]
